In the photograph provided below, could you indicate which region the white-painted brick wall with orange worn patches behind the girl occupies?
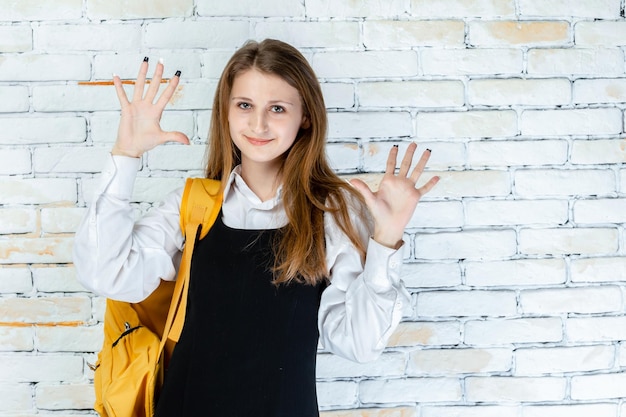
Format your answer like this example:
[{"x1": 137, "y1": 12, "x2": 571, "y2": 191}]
[{"x1": 0, "y1": 0, "x2": 626, "y2": 417}]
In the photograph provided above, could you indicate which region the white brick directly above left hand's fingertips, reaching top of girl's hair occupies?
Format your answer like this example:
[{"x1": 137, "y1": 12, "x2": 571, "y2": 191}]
[{"x1": 143, "y1": 20, "x2": 250, "y2": 49}]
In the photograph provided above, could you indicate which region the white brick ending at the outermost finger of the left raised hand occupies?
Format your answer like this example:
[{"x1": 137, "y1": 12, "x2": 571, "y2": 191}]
[{"x1": 33, "y1": 85, "x2": 120, "y2": 113}]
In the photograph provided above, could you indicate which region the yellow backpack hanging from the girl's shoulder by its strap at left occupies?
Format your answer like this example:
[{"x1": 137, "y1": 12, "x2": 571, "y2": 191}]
[{"x1": 90, "y1": 178, "x2": 222, "y2": 417}]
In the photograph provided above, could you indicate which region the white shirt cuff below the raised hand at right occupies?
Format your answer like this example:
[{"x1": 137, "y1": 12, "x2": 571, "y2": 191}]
[{"x1": 363, "y1": 238, "x2": 404, "y2": 292}]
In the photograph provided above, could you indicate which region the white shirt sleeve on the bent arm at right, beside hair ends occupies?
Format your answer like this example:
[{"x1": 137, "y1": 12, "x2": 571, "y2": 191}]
[{"x1": 318, "y1": 201, "x2": 411, "y2": 362}]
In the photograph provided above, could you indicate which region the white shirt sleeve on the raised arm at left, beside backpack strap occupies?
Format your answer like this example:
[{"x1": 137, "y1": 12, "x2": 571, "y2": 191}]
[{"x1": 73, "y1": 156, "x2": 184, "y2": 302}]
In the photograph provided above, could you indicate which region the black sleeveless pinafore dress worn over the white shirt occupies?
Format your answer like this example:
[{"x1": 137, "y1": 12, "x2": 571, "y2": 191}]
[{"x1": 155, "y1": 213, "x2": 324, "y2": 417}]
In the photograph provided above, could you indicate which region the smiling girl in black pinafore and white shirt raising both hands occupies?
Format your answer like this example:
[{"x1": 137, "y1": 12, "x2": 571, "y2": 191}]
[{"x1": 75, "y1": 40, "x2": 438, "y2": 417}]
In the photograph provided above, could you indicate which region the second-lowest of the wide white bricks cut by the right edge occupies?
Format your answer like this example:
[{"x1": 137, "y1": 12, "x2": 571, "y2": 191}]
[{"x1": 565, "y1": 316, "x2": 626, "y2": 343}]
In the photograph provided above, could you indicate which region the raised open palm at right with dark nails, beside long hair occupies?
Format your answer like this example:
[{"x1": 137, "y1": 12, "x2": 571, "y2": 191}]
[{"x1": 350, "y1": 143, "x2": 439, "y2": 249}]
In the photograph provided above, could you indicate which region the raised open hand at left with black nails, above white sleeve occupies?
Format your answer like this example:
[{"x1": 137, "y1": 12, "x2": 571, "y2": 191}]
[{"x1": 111, "y1": 58, "x2": 189, "y2": 158}]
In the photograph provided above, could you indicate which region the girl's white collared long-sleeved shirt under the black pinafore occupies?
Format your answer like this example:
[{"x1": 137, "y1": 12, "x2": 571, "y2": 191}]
[{"x1": 74, "y1": 156, "x2": 411, "y2": 362}]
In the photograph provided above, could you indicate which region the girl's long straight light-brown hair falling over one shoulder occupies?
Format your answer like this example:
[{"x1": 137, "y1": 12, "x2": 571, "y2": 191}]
[{"x1": 206, "y1": 39, "x2": 365, "y2": 284}]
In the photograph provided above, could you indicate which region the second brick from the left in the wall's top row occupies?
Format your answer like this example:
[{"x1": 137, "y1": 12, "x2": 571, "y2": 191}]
[{"x1": 87, "y1": 0, "x2": 193, "y2": 21}]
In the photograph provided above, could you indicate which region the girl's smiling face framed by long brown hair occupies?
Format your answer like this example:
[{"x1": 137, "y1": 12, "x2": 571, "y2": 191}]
[{"x1": 228, "y1": 68, "x2": 305, "y2": 170}]
